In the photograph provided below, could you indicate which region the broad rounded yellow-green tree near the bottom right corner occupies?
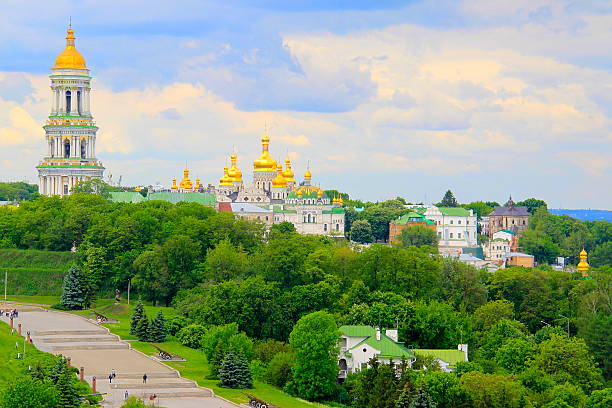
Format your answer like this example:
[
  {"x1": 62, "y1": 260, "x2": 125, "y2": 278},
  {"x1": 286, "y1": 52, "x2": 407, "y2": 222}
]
[{"x1": 533, "y1": 334, "x2": 602, "y2": 392}]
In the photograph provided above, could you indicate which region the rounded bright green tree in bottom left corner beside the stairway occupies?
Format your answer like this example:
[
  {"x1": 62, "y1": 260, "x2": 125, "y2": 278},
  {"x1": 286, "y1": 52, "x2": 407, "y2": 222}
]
[{"x1": 0, "y1": 377, "x2": 59, "y2": 408}]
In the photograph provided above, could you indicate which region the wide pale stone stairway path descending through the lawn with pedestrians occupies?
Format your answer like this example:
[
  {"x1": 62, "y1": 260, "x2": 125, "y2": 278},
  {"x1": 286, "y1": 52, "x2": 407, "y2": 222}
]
[{"x1": 0, "y1": 303, "x2": 238, "y2": 408}]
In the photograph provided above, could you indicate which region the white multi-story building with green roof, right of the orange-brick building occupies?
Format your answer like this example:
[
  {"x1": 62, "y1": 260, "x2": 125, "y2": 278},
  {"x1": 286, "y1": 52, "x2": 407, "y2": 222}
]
[{"x1": 423, "y1": 206, "x2": 478, "y2": 254}]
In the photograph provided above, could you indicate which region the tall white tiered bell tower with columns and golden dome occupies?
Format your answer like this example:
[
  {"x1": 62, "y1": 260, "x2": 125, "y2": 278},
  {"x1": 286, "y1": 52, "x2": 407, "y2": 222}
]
[{"x1": 36, "y1": 28, "x2": 104, "y2": 196}]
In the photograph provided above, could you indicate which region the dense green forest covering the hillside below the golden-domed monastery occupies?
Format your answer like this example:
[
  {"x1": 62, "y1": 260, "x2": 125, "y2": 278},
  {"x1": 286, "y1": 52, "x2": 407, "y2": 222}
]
[{"x1": 0, "y1": 194, "x2": 612, "y2": 408}]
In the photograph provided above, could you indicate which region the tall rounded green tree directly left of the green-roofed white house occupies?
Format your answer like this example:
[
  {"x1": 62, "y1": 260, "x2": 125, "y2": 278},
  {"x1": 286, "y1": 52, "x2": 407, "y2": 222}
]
[{"x1": 289, "y1": 311, "x2": 340, "y2": 401}]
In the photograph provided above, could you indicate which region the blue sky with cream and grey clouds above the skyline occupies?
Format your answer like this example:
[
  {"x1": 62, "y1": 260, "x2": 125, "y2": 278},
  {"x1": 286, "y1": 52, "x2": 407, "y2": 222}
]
[{"x1": 0, "y1": 0, "x2": 612, "y2": 209}]
